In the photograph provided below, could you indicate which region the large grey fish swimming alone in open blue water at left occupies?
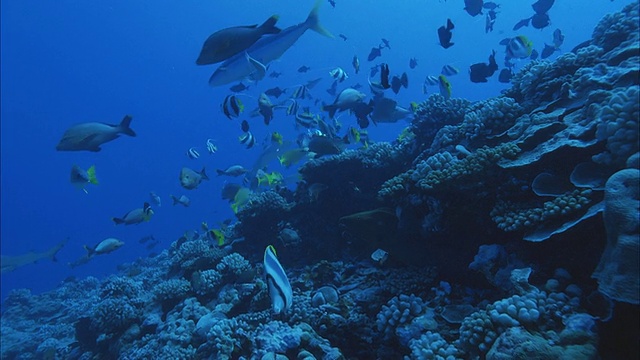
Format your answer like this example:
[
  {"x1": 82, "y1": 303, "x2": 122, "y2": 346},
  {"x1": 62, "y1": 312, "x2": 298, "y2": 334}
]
[{"x1": 56, "y1": 115, "x2": 136, "y2": 152}]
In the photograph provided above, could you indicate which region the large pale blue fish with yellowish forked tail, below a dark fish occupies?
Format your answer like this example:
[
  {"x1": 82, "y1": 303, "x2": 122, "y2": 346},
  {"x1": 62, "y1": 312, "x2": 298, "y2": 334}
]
[{"x1": 209, "y1": 0, "x2": 333, "y2": 86}]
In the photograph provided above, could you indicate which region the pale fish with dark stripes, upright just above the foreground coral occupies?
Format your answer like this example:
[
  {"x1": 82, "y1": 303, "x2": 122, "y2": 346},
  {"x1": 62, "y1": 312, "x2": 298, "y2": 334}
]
[{"x1": 263, "y1": 245, "x2": 293, "y2": 315}]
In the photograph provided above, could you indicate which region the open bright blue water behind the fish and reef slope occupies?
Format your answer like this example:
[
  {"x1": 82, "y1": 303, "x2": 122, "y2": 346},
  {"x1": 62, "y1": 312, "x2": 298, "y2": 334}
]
[{"x1": 0, "y1": 0, "x2": 632, "y2": 358}]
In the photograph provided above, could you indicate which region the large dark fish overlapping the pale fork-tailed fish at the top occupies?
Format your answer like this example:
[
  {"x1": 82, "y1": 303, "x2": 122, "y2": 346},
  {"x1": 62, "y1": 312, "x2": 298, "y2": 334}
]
[{"x1": 196, "y1": 15, "x2": 281, "y2": 65}]
